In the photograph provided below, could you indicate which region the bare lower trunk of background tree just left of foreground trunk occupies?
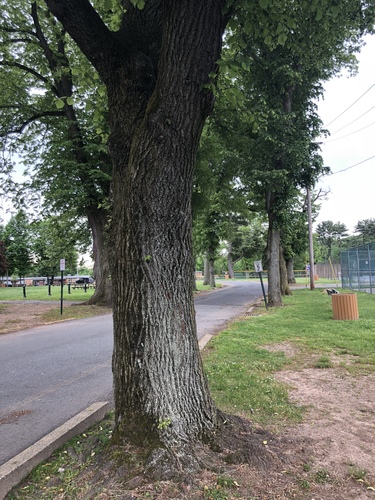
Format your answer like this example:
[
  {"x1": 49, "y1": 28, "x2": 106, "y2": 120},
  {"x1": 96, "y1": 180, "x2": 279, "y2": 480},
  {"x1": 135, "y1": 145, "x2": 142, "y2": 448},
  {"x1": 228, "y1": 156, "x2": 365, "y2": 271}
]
[{"x1": 85, "y1": 207, "x2": 112, "y2": 307}]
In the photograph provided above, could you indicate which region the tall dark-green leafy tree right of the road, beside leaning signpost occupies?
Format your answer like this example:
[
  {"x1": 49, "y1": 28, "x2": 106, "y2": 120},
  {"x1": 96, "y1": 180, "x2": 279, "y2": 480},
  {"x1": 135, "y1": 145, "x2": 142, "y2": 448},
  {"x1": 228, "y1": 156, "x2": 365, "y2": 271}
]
[{"x1": 217, "y1": 1, "x2": 371, "y2": 306}]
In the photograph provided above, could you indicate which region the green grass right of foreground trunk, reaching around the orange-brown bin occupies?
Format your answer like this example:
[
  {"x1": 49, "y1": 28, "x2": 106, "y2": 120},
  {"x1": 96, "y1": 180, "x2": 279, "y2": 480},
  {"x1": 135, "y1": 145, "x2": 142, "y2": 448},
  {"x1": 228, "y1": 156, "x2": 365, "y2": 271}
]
[{"x1": 204, "y1": 290, "x2": 375, "y2": 425}]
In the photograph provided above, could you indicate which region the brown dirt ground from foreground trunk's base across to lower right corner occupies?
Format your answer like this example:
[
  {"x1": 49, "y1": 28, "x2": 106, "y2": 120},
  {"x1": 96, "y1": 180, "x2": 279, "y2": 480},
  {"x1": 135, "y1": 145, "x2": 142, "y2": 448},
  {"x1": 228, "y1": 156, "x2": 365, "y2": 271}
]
[{"x1": 82, "y1": 343, "x2": 375, "y2": 500}]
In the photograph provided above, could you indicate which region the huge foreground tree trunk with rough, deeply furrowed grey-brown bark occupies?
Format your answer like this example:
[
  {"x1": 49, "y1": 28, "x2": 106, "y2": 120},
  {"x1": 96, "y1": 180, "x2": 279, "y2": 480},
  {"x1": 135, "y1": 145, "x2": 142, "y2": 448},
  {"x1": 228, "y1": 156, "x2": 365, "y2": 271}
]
[{"x1": 46, "y1": 0, "x2": 224, "y2": 464}]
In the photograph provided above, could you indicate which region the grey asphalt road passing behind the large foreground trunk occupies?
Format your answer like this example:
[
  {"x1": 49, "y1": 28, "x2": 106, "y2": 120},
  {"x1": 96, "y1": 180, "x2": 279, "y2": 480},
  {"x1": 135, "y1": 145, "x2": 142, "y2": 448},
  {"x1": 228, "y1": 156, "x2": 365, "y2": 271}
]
[{"x1": 0, "y1": 281, "x2": 262, "y2": 465}]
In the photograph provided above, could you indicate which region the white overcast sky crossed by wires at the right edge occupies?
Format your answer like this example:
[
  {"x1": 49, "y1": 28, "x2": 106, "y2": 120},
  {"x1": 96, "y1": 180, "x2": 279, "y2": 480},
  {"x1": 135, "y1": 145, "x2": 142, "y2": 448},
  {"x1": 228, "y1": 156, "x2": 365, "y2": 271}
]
[{"x1": 315, "y1": 36, "x2": 375, "y2": 232}]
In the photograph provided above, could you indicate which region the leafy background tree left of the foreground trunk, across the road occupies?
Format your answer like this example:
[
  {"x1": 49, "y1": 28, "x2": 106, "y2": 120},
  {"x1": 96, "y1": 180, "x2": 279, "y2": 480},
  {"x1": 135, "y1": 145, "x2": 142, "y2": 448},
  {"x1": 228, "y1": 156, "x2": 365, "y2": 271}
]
[{"x1": 0, "y1": 0, "x2": 111, "y2": 304}]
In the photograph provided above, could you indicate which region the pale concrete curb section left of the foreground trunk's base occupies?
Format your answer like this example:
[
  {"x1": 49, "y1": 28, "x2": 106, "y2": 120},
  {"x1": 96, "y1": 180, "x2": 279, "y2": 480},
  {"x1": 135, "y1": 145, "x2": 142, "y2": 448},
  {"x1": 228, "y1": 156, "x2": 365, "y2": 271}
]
[{"x1": 0, "y1": 402, "x2": 110, "y2": 500}]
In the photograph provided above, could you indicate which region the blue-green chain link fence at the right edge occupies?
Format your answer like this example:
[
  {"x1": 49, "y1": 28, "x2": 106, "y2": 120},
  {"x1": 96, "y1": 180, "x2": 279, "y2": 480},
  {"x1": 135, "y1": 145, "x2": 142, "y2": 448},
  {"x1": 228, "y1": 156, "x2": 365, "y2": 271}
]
[{"x1": 340, "y1": 243, "x2": 375, "y2": 293}]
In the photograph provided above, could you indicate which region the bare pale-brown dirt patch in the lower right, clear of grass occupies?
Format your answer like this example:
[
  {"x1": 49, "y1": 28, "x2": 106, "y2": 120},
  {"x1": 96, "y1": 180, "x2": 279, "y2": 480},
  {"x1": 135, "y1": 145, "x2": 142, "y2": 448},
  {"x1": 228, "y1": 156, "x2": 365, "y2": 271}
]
[{"x1": 276, "y1": 368, "x2": 375, "y2": 499}]
